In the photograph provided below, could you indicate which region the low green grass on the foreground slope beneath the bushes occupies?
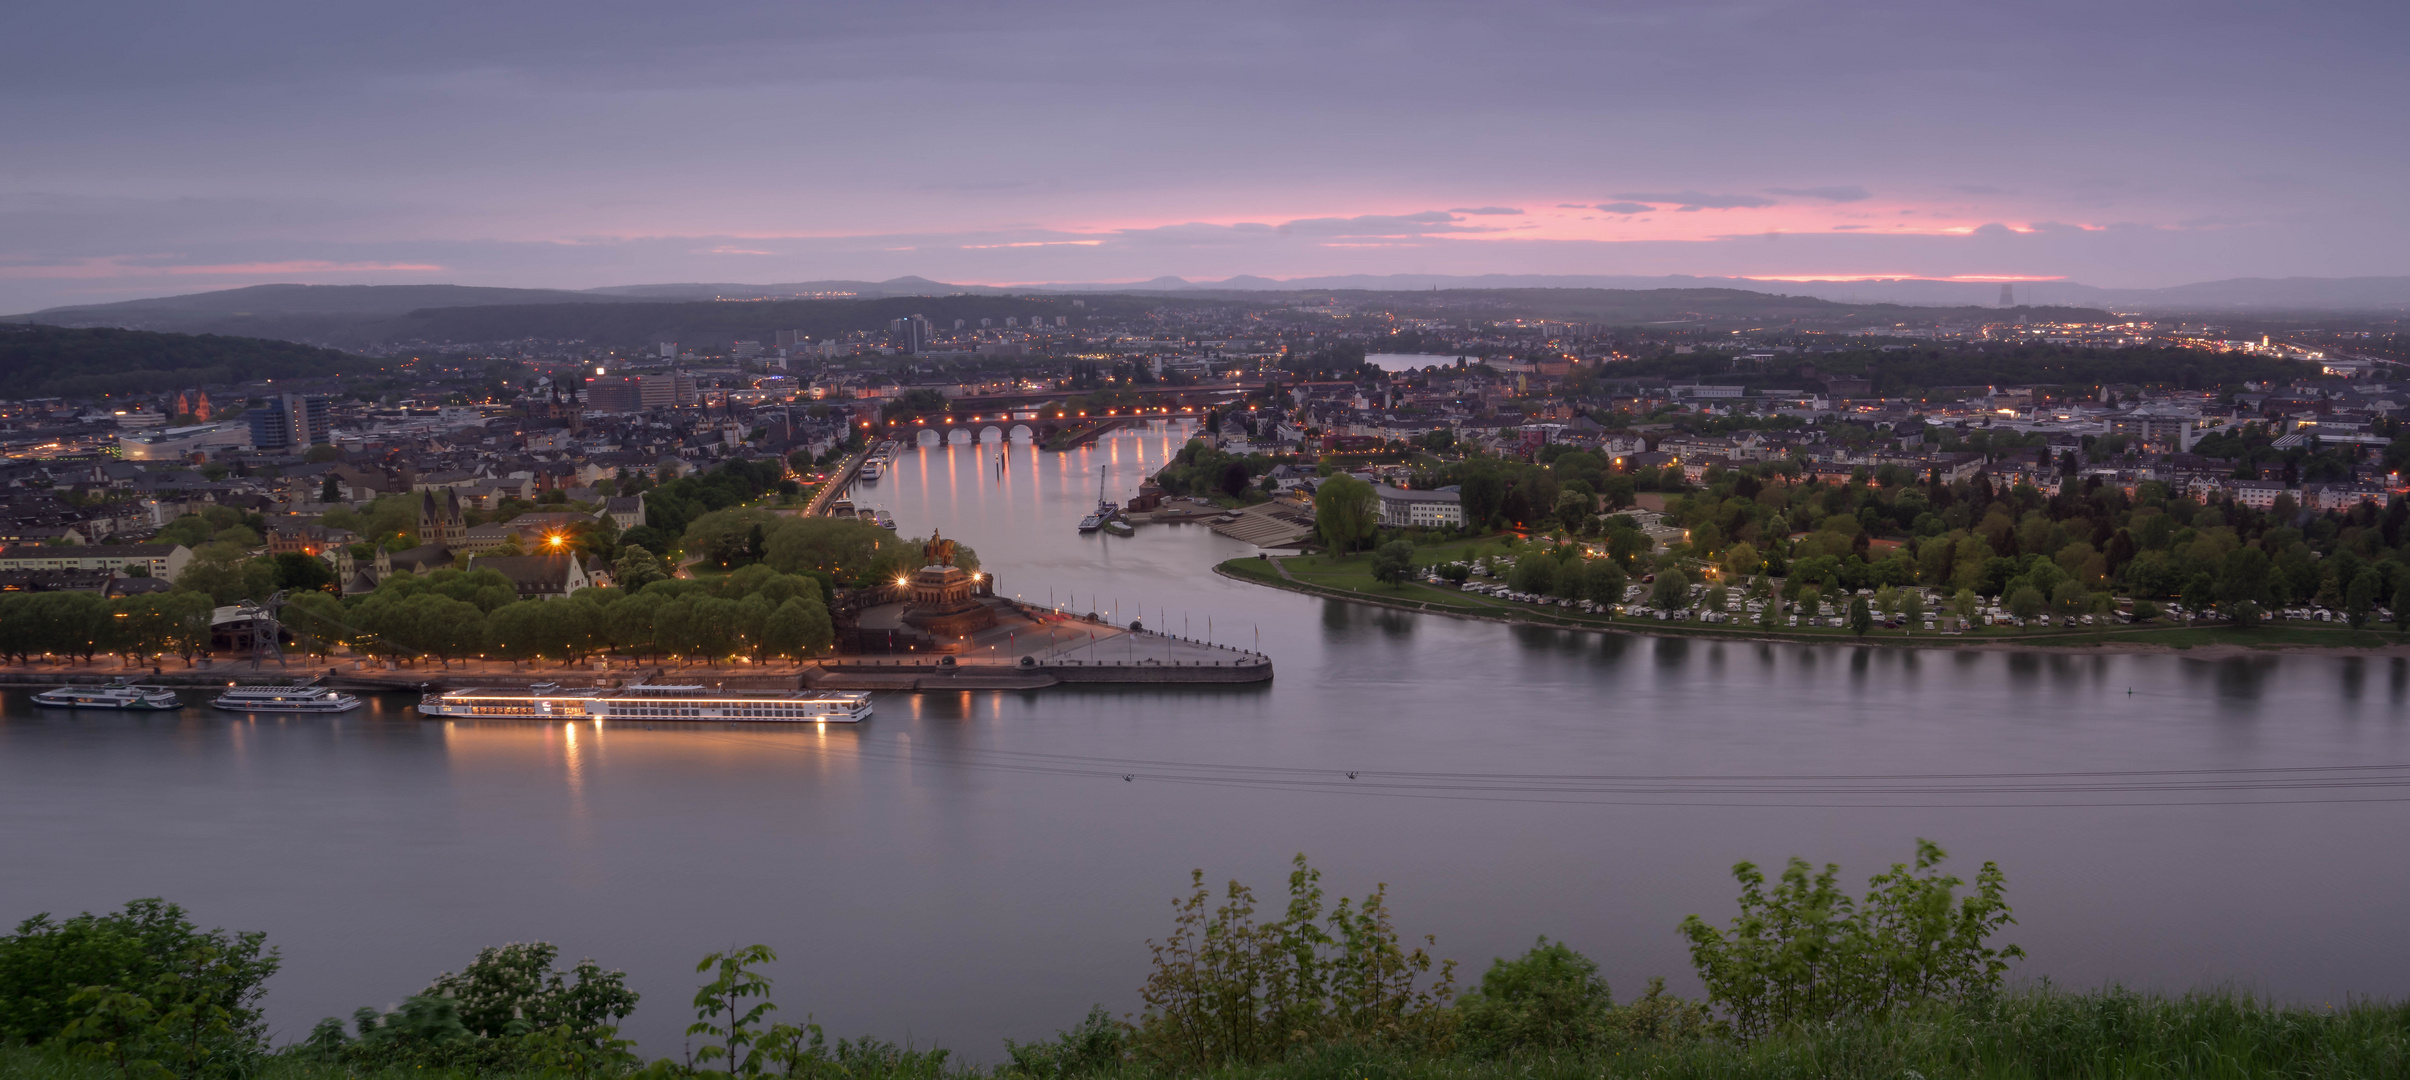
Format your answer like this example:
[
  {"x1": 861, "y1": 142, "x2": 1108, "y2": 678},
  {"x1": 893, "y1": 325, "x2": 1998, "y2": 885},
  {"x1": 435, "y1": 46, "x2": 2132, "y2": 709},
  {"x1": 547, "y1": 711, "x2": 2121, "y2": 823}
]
[{"x1": 0, "y1": 988, "x2": 2410, "y2": 1080}]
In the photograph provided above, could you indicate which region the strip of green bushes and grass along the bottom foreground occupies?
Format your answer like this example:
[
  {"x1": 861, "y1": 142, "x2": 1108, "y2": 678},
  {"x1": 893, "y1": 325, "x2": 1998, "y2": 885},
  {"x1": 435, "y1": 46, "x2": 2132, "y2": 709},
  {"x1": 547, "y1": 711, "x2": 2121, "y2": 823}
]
[{"x1": 0, "y1": 841, "x2": 2410, "y2": 1080}]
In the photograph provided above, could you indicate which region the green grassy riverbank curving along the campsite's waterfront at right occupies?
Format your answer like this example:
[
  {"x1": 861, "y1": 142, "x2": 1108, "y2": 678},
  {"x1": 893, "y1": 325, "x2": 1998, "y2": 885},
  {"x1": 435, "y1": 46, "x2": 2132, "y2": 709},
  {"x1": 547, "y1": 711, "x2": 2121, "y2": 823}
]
[{"x1": 1215, "y1": 557, "x2": 2410, "y2": 658}]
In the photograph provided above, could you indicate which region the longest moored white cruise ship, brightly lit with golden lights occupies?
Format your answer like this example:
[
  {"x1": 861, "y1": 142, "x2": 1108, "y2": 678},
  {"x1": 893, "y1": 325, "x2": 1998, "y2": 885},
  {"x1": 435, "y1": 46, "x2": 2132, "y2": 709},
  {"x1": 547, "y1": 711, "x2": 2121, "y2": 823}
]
[{"x1": 419, "y1": 682, "x2": 870, "y2": 723}]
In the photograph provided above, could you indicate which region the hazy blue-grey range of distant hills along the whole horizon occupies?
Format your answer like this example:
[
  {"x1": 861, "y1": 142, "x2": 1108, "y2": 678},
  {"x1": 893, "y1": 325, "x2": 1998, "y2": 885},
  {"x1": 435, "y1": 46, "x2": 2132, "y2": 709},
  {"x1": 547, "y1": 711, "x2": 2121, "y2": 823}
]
[{"x1": 23, "y1": 275, "x2": 2410, "y2": 350}]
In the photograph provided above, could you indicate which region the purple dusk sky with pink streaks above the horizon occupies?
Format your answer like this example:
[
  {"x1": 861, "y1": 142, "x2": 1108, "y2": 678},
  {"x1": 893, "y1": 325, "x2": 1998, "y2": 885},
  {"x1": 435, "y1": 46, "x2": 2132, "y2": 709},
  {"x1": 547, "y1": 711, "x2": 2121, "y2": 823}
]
[{"x1": 0, "y1": 0, "x2": 2410, "y2": 311}]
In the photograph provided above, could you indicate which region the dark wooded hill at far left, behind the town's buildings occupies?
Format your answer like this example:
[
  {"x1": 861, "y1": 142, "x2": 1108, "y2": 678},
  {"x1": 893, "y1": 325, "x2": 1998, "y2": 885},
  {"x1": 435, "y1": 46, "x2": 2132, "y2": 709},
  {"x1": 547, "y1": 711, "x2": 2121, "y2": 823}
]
[{"x1": 0, "y1": 325, "x2": 376, "y2": 400}]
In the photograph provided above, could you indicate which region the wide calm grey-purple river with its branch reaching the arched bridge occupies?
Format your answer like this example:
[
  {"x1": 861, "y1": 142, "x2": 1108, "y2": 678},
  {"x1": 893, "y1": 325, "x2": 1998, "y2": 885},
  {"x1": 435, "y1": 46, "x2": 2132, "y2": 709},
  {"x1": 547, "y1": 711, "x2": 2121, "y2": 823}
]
[{"x1": 0, "y1": 429, "x2": 2410, "y2": 1058}]
